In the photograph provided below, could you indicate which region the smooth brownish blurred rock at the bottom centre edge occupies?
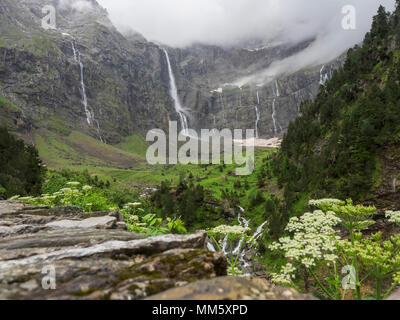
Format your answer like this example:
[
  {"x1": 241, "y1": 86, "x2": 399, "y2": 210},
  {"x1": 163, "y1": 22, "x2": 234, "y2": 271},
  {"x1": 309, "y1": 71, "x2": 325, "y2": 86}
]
[{"x1": 147, "y1": 277, "x2": 316, "y2": 300}]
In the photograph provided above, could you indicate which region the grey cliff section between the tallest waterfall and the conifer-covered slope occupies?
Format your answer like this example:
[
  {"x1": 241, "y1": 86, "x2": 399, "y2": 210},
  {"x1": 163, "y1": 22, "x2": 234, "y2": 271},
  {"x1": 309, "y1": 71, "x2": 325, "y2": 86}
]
[{"x1": 166, "y1": 39, "x2": 344, "y2": 138}]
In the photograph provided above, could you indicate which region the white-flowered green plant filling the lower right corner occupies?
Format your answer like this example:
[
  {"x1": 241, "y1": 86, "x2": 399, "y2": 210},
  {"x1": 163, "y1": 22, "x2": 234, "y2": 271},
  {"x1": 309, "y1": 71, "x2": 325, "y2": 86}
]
[{"x1": 269, "y1": 199, "x2": 400, "y2": 300}]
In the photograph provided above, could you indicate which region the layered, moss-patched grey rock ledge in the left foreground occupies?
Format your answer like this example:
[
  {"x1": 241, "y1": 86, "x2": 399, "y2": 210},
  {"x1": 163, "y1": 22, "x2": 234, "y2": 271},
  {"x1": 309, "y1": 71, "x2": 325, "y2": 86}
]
[{"x1": 0, "y1": 201, "x2": 227, "y2": 299}]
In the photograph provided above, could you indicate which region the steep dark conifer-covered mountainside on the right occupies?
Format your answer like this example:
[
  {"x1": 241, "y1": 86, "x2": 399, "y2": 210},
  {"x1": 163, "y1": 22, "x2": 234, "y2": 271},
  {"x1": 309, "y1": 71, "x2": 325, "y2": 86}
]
[{"x1": 275, "y1": 5, "x2": 400, "y2": 209}]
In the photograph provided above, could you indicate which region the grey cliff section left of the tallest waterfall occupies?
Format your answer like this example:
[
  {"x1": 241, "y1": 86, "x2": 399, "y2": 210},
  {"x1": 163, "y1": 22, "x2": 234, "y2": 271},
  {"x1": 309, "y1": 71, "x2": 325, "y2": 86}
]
[{"x1": 0, "y1": 0, "x2": 174, "y2": 143}]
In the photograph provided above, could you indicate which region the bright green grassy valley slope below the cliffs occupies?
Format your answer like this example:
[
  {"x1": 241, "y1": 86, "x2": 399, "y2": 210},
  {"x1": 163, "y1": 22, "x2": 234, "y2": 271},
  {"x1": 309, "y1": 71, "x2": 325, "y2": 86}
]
[{"x1": 35, "y1": 126, "x2": 279, "y2": 225}]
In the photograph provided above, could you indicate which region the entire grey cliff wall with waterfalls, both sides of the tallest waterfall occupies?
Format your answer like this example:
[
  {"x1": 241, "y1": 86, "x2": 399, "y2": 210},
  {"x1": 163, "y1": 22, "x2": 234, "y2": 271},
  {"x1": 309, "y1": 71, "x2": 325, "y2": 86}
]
[{"x1": 0, "y1": 0, "x2": 341, "y2": 144}]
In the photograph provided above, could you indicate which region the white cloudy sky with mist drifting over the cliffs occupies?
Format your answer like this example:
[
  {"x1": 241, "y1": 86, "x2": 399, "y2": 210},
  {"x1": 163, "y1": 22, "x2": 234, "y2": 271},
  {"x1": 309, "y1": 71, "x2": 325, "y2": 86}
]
[{"x1": 93, "y1": 0, "x2": 395, "y2": 86}]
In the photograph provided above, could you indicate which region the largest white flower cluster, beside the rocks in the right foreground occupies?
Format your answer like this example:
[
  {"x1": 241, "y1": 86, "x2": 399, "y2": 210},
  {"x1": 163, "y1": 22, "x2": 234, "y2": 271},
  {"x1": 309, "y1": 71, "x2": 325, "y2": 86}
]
[{"x1": 269, "y1": 210, "x2": 341, "y2": 284}]
